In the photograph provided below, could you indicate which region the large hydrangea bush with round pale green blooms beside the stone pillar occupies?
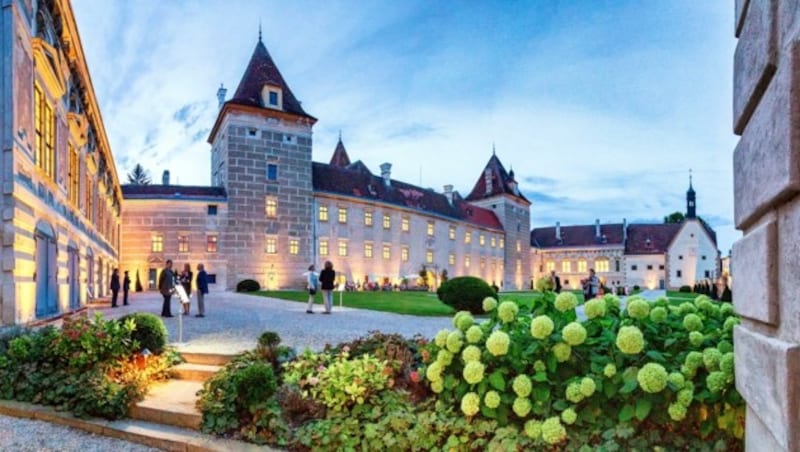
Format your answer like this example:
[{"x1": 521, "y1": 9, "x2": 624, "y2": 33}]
[{"x1": 419, "y1": 292, "x2": 744, "y2": 450}]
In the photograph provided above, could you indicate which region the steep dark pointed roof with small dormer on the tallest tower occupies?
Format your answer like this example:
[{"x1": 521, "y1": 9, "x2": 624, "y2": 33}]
[{"x1": 228, "y1": 38, "x2": 316, "y2": 119}]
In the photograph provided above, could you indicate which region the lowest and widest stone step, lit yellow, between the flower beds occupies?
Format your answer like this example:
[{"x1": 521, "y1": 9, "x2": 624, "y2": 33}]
[{"x1": 130, "y1": 380, "x2": 203, "y2": 430}]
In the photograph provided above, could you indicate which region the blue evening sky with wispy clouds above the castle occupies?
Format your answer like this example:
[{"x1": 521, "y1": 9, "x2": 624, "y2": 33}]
[{"x1": 73, "y1": 0, "x2": 739, "y2": 254}]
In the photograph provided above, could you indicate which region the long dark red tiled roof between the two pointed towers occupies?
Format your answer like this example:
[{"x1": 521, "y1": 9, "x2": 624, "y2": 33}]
[{"x1": 313, "y1": 160, "x2": 503, "y2": 231}]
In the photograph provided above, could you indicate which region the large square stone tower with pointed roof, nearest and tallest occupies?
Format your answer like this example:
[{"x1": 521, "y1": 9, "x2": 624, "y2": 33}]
[{"x1": 207, "y1": 33, "x2": 317, "y2": 289}]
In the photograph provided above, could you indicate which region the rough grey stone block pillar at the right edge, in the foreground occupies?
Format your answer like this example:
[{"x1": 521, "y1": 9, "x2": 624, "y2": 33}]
[{"x1": 731, "y1": 0, "x2": 800, "y2": 451}]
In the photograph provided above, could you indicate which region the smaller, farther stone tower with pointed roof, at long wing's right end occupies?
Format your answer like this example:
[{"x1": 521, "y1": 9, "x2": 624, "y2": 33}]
[{"x1": 466, "y1": 152, "x2": 531, "y2": 290}]
